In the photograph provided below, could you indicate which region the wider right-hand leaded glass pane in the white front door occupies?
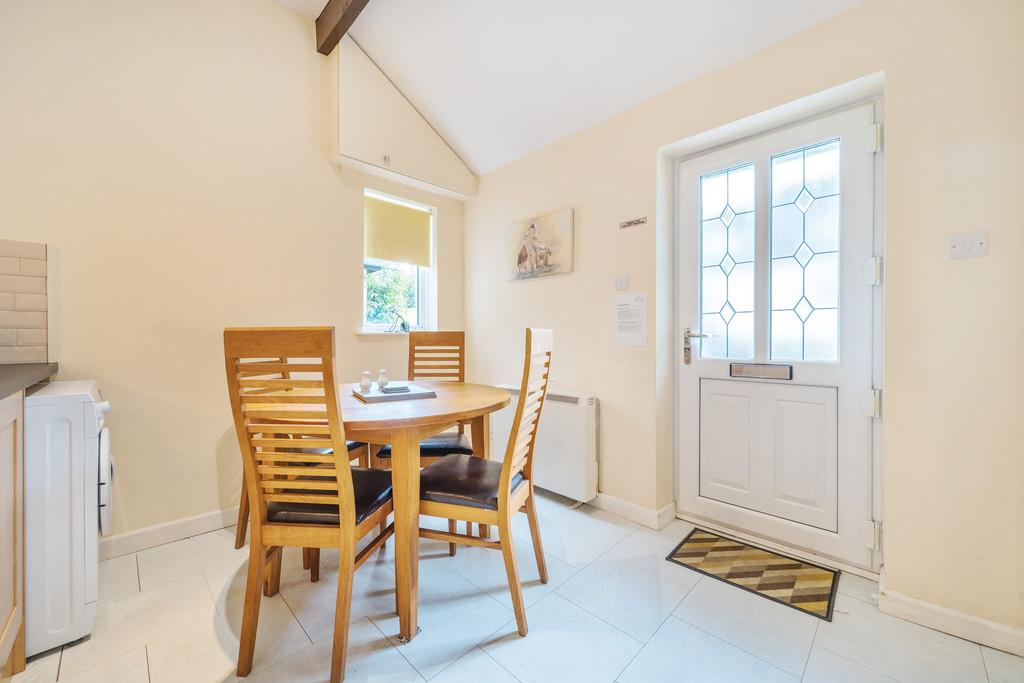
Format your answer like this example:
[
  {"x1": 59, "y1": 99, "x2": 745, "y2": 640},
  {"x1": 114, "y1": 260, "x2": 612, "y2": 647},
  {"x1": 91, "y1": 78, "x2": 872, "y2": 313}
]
[{"x1": 770, "y1": 140, "x2": 840, "y2": 361}]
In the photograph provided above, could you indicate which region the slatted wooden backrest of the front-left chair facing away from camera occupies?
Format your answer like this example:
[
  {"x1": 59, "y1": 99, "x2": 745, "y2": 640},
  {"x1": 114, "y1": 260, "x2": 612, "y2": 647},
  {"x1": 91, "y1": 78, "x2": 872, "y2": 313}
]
[{"x1": 224, "y1": 327, "x2": 355, "y2": 533}]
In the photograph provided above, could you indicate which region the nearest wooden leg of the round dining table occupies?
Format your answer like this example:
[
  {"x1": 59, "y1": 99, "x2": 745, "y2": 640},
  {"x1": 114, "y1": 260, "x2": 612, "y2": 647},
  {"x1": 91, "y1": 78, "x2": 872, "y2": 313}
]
[{"x1": 391, "y1": 429, "x2": 420, "y2": 643}]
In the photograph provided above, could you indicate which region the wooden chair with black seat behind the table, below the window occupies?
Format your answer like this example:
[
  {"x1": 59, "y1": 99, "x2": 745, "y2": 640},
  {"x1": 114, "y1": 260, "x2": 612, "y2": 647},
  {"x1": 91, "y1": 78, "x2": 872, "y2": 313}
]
[{"x1": 370, "y1": 332, "x2": 473, "y2": 468}]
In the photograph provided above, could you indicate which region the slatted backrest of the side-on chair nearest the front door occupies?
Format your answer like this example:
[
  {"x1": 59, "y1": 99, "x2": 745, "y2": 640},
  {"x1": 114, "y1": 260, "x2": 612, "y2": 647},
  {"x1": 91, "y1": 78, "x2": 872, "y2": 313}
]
[{"x1": 499, "y1": 328, "x2": 554, "y2": 493}]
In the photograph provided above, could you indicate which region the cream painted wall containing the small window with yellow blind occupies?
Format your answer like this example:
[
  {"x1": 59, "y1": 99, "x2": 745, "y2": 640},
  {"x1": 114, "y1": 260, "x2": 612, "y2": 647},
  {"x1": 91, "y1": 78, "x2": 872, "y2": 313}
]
[{"x1": 0, "y1": 0, "x2": 464, "y2": 531}]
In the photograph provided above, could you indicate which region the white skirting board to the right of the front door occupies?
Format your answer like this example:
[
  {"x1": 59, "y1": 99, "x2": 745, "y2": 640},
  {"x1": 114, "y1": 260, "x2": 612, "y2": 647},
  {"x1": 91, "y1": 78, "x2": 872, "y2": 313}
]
[{"x1": 879, "y1": 570, "x2": 1024, "y2": 656}]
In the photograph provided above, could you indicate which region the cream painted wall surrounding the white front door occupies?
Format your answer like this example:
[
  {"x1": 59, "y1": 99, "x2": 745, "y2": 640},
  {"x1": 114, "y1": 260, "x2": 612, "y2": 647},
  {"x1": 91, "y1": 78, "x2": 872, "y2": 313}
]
[{"x1": 466, "y1": 0, "x2": 1024, "y2": 629}]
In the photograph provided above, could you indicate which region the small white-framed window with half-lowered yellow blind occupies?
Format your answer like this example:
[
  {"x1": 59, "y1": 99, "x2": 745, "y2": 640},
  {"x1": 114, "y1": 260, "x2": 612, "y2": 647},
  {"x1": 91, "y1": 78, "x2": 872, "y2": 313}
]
[{"x1": 362, "y1": 189, "x2": 436, "y2": 332}]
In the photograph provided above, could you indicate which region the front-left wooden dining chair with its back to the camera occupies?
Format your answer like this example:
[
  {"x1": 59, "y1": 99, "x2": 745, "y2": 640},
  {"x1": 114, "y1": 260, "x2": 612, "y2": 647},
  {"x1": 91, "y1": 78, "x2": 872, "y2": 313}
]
[{"x1": 224, "y1": 328, "x2": 394, "y2": 683}]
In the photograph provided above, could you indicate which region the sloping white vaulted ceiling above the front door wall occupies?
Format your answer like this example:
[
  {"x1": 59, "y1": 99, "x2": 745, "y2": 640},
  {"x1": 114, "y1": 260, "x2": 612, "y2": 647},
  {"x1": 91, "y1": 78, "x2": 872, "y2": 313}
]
[{"x1": 280, "y1": 0, "x2": 861, "y2": 173}]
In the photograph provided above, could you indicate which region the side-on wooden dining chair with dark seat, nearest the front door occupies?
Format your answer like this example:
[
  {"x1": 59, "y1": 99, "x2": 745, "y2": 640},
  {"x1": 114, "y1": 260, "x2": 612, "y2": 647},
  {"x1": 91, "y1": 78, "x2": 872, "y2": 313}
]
[{"x1": 420, "y1": 329, "x2": 553, "y2": 636}]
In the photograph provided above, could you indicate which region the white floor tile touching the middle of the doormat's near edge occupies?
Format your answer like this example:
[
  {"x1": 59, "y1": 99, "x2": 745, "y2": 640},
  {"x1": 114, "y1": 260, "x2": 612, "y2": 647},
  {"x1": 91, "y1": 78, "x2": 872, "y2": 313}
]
[{"x1": 675, "y1": 577, "x2": 820, "y2": 676}]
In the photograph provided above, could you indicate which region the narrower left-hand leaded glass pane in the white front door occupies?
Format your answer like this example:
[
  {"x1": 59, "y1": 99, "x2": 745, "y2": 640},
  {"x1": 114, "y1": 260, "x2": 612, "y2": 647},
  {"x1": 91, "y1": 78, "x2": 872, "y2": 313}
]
[{"x1": 700, "y1": 164, "x2": 754, "y2": 358}]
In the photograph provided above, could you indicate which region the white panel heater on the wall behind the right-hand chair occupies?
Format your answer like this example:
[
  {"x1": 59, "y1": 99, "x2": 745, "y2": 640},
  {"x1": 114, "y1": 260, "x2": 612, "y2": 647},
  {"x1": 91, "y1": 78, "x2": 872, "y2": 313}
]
[{"x1": 490, "y1": 384, "x2": 600, "y2": 502}]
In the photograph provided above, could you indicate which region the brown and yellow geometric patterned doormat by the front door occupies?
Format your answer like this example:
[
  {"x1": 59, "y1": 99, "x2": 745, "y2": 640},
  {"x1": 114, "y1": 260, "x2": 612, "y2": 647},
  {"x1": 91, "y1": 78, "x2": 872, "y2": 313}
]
[{"x1": 665, "y1": 528, "x2": 840, "y2": 622}]
